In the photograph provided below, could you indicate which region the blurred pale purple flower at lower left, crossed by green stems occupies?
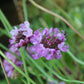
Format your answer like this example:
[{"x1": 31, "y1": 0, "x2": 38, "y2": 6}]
[{"x1": 3, "y1": 45, "x2": 23, "y2": 77}]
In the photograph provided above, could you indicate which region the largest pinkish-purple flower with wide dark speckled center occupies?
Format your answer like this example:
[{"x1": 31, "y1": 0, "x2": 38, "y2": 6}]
[{"x1": 28, "y1": 28, "x2": 69, "y2": 60}]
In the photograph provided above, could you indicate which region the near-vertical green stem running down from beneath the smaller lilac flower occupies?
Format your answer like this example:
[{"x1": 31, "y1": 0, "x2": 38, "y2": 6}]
[{"x1": 20, "y1": 48, "x2": 30, "y2": 84}]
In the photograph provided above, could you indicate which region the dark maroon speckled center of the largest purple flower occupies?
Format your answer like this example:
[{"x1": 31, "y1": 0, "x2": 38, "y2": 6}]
[{"x1": 41, "y1": 35, "x2": 61, "y2": 49}]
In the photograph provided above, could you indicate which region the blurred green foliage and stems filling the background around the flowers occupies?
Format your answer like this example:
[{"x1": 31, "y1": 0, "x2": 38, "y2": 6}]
[{"x1": 0, "y1": 0, "x2": 84, "y2": 84}]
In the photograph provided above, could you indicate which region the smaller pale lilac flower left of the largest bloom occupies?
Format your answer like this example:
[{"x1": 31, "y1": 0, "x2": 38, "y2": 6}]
[{"x1": 9, "y1": 21, "x2": 33, "y2": 48}]
